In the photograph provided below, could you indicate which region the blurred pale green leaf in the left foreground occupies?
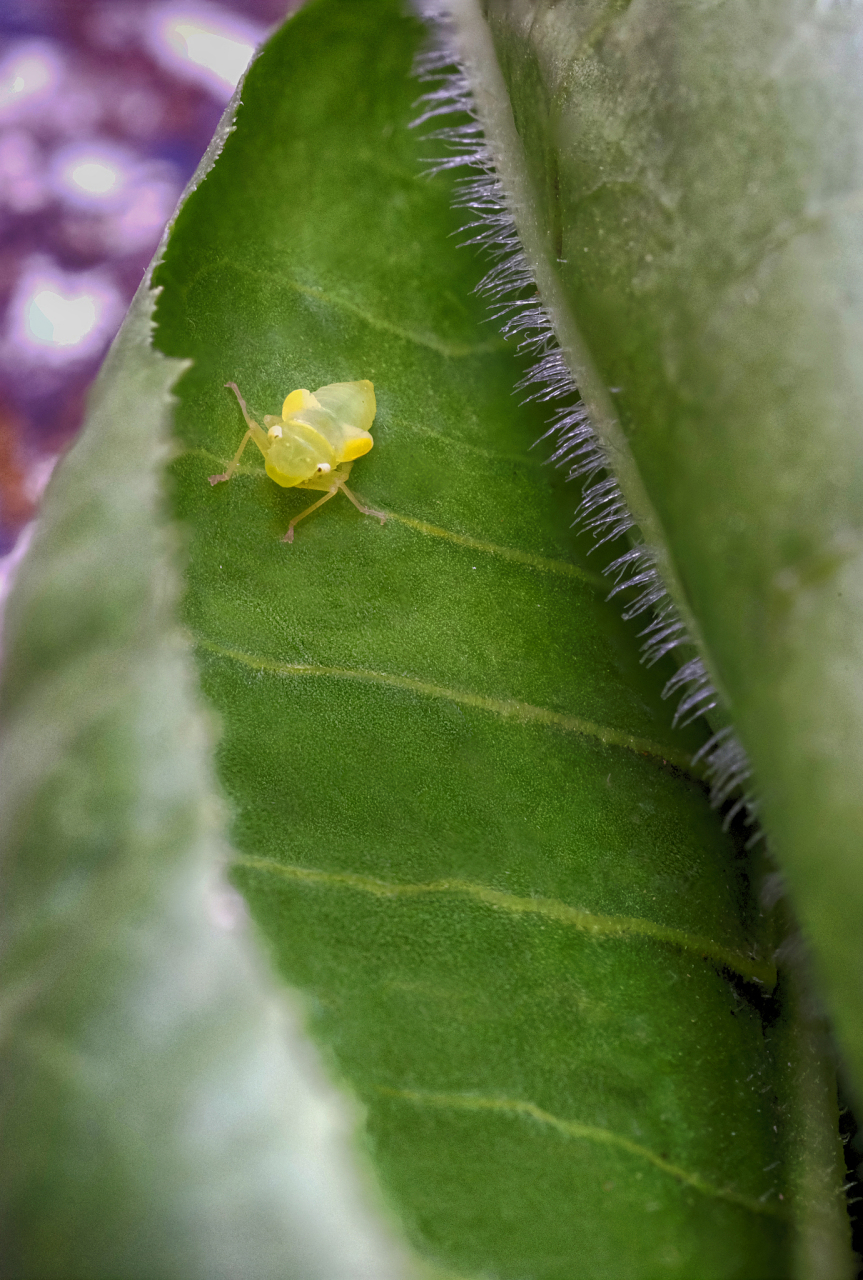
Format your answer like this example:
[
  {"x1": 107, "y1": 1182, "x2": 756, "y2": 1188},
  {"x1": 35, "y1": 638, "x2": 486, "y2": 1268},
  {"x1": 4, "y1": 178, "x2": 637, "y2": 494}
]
[{"x1": 0, "y1": 183, "x2": 405, "y2": 1280}]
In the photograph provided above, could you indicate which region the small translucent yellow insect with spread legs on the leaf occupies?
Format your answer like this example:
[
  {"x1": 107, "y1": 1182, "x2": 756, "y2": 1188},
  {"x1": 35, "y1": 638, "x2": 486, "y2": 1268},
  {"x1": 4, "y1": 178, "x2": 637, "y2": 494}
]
[{"x1": 210, "y1": 380, "x2": 387, "y2": 543}]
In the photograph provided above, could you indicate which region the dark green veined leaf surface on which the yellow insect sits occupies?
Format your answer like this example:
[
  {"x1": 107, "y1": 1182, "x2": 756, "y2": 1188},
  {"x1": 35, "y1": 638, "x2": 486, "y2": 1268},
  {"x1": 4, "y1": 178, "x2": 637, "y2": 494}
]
[{"x1": 149, "y1": 0, "x2": 844, "y2": 1280}]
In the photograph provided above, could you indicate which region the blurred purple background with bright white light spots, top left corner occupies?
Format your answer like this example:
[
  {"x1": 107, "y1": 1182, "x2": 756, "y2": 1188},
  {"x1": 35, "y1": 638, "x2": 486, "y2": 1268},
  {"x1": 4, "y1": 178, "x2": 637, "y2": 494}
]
[{"x1": 0, "y1": 0, "x2": 296, "y2": 576}]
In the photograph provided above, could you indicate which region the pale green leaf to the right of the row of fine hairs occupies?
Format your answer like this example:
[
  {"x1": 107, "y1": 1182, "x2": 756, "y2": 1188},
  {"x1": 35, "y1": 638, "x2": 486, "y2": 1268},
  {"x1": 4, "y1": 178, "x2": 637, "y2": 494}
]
[{"x1": 453, "y1": 0, "x2": 863, "y2": 1096}]
